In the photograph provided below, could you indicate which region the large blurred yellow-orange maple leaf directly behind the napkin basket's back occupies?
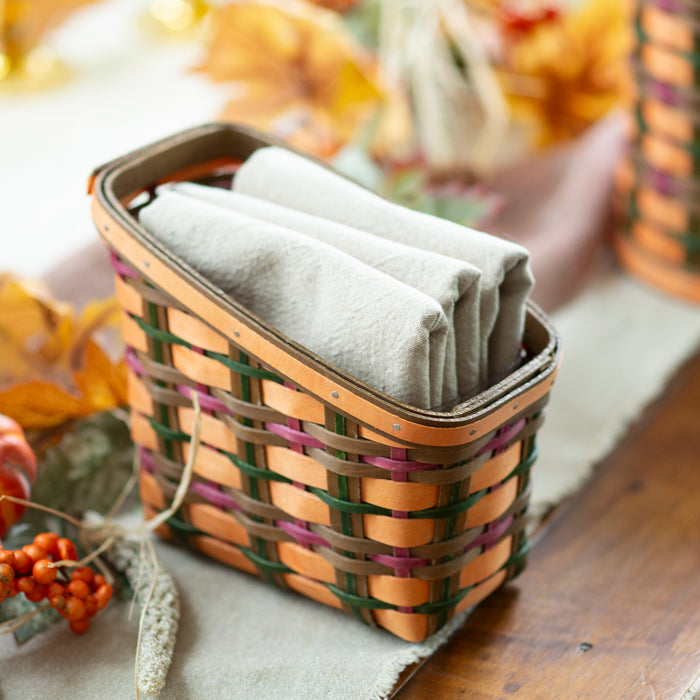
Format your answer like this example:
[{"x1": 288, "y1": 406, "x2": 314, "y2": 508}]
[{"x1": 198, "y1": 1, "x2": 383, "y2": 156}]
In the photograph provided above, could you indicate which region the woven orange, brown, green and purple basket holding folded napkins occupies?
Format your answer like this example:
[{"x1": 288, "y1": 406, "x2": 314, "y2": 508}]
[{"x1": 90, "y1": 124, "x2": 558, "y2": 641}]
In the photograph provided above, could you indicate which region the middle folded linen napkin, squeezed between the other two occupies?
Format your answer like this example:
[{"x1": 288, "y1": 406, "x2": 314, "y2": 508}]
[{"x1": 172, "y1": 182, "x2": 481, "y2": 404}]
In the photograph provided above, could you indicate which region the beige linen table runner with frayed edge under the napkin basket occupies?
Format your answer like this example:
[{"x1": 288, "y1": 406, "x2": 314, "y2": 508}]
[{"x1": 0, "y1": 270, "x2": 700, "y2": 700}]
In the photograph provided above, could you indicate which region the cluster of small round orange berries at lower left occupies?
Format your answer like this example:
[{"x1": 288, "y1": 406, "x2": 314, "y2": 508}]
[{"x1": 0, "y1": 532, "x2": 112, "y2": 634}]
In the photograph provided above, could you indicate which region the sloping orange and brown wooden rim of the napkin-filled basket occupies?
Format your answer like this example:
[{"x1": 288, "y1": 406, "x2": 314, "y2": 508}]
[{"x1": 89, "y1": 123, "x2": 560, "y2": 446}]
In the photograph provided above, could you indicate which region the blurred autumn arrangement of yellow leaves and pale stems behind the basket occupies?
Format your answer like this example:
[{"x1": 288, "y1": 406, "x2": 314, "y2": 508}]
[{"x1": 190, "y1": 0, "x2": 631, "y2": 223}]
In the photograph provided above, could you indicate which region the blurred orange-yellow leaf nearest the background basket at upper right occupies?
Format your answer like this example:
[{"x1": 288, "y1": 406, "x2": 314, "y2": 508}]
[{"x1": 501, "y1": 0, "x2": 631, "y2": 146}]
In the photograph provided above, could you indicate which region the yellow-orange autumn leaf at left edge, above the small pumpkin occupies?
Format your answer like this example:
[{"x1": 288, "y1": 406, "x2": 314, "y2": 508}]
[{"x1": 0, "y1": 275, "x2": 126, "y2": 429}]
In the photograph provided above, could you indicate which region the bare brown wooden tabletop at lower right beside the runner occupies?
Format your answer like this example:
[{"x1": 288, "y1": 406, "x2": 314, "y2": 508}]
[{"x1": 392, "y1": 355, "x2": 700, "y2": 700}]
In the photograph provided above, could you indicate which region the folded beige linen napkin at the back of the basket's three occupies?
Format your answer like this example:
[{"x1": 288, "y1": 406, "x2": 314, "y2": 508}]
[{"x1": 233, "y1": 147, "x2": 534, "y2": 384}]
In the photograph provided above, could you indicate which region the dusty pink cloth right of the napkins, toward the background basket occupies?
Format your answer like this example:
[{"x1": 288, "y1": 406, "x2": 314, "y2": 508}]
[{"x1": 480, "y1": 114, "x2": 624, "y2": 311}]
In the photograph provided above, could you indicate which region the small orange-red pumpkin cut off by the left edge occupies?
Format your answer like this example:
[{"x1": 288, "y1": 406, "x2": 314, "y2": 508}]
[{"x1": 0, "y1": 413, "x2": 36, "y2": 537}]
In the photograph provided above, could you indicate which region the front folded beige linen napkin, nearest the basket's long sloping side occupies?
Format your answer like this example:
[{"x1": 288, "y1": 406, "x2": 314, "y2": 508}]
[{"x1": 139, "y1": 191, "x2": 448, "y2": 408}]
